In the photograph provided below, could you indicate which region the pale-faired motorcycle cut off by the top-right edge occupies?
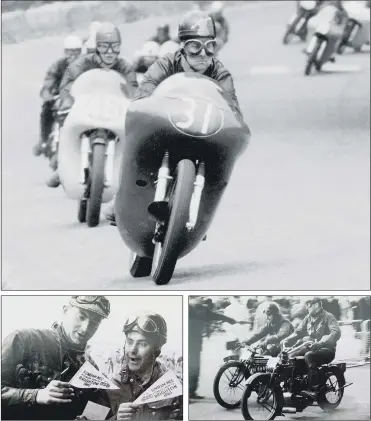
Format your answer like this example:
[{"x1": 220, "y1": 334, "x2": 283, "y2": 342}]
[{"x1": 337, "y1": 1, "x2": 370, "y2": 54}]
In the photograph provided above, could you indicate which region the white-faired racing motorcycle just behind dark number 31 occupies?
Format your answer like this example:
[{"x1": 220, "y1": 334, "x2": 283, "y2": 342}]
[{"x1": 58, "y1": 69, "x2": 130, "y2": 227}]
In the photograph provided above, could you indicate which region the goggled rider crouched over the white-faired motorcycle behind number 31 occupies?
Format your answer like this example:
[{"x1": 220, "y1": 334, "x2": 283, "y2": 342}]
[{"x1": 50, "y1": 22, "x2": 138, "y2": 187}]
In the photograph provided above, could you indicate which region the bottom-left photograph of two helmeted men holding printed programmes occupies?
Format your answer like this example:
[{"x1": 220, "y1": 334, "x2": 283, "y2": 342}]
[{"x1": 1, "y1": 295, "x2": 183, "y2": 421}]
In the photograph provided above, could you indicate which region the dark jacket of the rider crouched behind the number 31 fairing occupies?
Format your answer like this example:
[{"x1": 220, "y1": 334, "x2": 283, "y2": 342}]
[{"x1": 136, "y1": 50, "x2": 246, "y2": 119}]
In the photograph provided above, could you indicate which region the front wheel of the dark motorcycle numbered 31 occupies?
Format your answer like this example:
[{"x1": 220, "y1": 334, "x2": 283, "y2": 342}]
[{"x1": 152, "y1": 159, "x2": 196, "y2": 285}]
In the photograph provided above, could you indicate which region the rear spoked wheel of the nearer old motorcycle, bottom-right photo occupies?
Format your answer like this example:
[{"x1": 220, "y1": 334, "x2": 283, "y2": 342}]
[{"x1": 317, "y1": 371, "x2": 345, "y2": 412}]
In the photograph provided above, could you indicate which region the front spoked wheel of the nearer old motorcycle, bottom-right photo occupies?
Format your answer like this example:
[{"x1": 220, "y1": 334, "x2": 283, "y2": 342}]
[{"x1": 241, "y1": 374, "x2": 280, "y2": 420}]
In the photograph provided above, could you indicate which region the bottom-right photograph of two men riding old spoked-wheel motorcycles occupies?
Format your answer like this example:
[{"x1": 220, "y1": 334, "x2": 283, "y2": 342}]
[{"x1": 188, "y1": 295, "x2": 371, "y2": 420}]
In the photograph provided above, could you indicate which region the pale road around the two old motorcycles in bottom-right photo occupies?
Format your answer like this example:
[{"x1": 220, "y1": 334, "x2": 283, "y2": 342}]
[{"x1": 188, "y1": 326, "x2": 370, "y2": 420}]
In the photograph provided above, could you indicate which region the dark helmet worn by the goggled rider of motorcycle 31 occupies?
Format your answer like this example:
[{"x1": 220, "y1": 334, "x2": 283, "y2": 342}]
[{"x1": 178, "y1": 11, "x2": 216, "y2": 41}]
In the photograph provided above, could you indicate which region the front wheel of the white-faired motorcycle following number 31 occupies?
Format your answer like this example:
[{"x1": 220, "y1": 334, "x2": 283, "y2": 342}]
[{"x1": 86, "y1": 143, "x2": 106, "y2": 227}]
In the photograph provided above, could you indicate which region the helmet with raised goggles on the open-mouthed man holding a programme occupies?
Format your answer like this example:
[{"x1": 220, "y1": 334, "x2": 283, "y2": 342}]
[{"x1": 123, "y1": 313, "x2": 167, "y2": 347}]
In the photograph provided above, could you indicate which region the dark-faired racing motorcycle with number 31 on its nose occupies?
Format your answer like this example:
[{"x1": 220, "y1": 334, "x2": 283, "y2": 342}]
[{"x1": 115, "y1": 73, "x2": 250, "y2": 285}]
